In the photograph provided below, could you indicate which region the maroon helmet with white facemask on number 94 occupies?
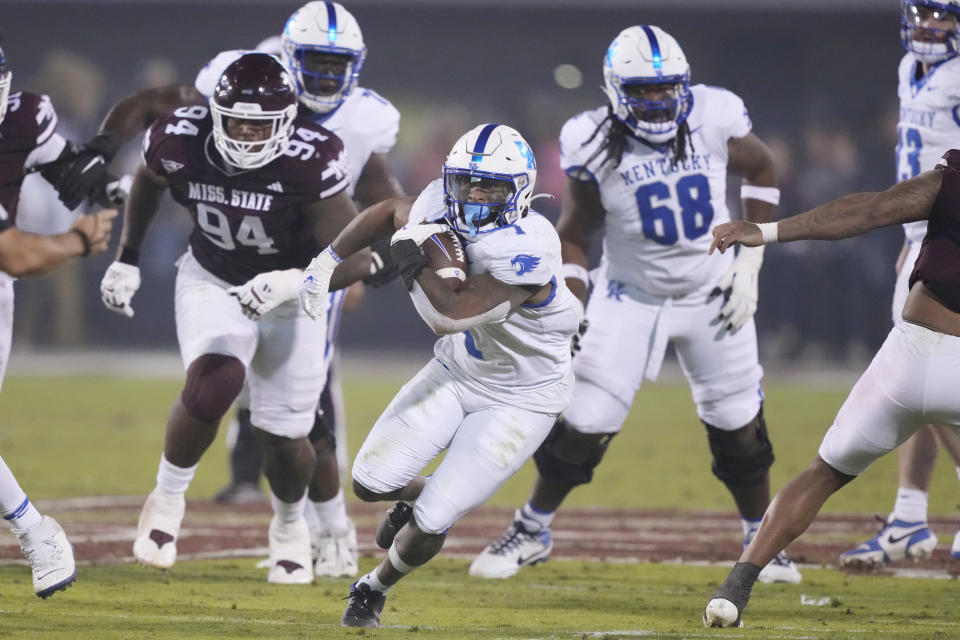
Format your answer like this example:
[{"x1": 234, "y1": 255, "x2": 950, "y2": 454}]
[{"x1": 210, "y1": 53, "x2": 297, "y2": 169}]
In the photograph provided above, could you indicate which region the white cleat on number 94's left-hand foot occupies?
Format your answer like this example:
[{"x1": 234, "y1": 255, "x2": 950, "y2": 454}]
[{"x1": 133, "y1": 488, "x2": 186, "y2": 569}]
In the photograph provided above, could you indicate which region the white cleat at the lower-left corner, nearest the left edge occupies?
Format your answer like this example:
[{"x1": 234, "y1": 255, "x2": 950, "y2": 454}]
[{"x1": 13, "y1": 516, "x2": 77, "y2": 600}]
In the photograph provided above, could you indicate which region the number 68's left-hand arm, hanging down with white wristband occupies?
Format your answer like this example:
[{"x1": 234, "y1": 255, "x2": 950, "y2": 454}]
[{"x1": 557, "y1": 176, "x2": 605, "y2": 304}]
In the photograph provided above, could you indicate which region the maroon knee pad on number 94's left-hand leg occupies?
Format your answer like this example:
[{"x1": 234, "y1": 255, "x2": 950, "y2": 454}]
[{"x1": 180, "y1": 353, "x2": 246, "y2": 422}]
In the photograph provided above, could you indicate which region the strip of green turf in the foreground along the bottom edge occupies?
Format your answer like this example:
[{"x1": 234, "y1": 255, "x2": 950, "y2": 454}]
[{"x1": 0, "y1": 558, "x2": 960, "y2": 640}]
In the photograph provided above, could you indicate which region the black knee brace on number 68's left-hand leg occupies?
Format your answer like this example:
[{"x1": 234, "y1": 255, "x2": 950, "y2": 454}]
[{"x1": 533, "y1": 418, "x2": 617, "y2": 487}]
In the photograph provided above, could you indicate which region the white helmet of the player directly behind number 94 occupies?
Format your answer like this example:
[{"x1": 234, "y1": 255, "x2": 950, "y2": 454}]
[{"x1": 281, "y1": 1, "x2": 367, "y2": 113}]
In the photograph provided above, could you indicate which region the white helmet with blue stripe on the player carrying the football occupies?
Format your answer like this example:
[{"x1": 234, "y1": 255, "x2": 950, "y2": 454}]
[{"x1": 443, "y1": 124, "x2": 537, "y2": 238}]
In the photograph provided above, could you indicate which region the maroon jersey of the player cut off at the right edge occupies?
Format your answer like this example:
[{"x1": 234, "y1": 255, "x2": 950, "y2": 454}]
[{"x1": 910, "y1": 149, "x2": 960, "y2": 313}]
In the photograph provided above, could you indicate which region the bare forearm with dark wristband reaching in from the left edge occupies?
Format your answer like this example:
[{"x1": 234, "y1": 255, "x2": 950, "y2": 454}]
[{"x1": 0, "y1": 209, "x2": 117, "y2": 278}]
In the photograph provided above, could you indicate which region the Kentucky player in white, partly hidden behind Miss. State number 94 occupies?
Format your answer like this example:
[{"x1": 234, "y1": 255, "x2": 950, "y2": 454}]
[{"x1": 73, "y1": 2, "x2": 403, "y2": 577}]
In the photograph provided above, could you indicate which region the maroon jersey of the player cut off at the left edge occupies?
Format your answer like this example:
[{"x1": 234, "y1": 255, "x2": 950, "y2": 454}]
[{"x1": 0, "y1": 91, "x2": 63, "y2": 231}]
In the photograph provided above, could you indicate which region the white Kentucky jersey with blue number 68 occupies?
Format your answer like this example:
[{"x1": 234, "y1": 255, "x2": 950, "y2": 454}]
[{"x1": 560, "y1": 85, "x2": 751, "y2": 297}]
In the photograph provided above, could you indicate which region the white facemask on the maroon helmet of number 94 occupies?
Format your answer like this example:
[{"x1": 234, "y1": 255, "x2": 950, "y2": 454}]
[{"x1": 210, "y1": 99, "x2": 297, "y2": 169}]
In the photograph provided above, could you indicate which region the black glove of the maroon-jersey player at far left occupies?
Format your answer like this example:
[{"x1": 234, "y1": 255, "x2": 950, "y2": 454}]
[{"x1": 49, "y1": 132, "x2": 120, "y2": 209}]
